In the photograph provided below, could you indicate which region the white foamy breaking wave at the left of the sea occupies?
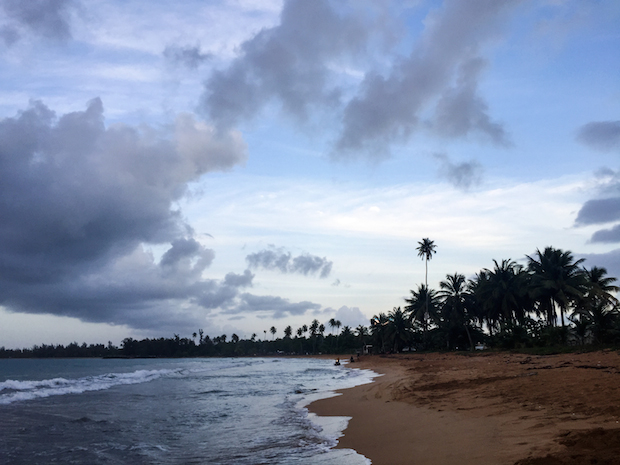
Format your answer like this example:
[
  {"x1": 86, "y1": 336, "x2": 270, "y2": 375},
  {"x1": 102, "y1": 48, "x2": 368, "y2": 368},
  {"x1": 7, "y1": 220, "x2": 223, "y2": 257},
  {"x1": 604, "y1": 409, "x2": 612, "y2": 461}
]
[{"x1": 0, "y1": 370, "x2": 177, "y2": 405}]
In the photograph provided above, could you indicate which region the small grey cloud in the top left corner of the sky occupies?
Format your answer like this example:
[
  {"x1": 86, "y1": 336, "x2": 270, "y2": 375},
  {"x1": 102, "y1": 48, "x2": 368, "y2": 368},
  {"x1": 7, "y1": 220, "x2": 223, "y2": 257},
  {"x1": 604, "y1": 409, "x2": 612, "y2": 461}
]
[{"x1": 0, "y1": 0, "x2": 78, "y2": 45}]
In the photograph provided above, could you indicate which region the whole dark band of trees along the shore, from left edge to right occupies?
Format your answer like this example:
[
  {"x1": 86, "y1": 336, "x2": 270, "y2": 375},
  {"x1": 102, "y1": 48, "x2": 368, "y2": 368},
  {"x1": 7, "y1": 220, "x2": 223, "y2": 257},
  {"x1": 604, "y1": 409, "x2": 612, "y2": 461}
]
[{"x1": 0, "y1": 239, "x2": 620, "y2": 357}]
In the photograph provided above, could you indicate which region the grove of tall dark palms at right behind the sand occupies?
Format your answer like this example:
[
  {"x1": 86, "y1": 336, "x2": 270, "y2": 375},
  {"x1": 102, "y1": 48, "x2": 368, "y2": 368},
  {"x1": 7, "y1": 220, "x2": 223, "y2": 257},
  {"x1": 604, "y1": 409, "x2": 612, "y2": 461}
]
[{"x1": 371, "y1": 239, "x2": 620, "y2": 352}]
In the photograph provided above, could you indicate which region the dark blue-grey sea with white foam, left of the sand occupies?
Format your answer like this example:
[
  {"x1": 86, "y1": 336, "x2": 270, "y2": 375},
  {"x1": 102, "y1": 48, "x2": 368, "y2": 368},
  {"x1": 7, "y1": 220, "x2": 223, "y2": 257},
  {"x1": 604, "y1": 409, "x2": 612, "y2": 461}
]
[{"x1": 0, "y1": 358, "x2": 375, "y2": 465}]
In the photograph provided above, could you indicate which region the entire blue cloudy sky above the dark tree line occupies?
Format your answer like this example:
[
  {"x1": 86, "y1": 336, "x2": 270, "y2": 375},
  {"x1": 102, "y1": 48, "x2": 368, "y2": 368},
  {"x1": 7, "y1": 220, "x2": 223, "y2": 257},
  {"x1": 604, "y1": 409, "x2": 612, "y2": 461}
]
[{"x1": 0, "y1": 0, "x2": 620, "y2": 348}]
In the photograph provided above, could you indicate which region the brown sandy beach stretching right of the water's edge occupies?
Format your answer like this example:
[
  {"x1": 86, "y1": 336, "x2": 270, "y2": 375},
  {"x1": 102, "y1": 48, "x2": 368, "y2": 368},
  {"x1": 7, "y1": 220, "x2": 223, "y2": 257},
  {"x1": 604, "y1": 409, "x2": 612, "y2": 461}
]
[{"x1": 309, "y1": 351, "x2": 620, "y2": 465}]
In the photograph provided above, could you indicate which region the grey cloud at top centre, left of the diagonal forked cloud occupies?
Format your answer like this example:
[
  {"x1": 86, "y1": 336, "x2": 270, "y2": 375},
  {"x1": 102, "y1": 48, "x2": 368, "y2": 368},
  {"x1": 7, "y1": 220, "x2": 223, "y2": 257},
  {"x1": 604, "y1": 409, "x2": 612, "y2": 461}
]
[{"x1": 203, "y1": 0, "x2": 370, "y2": 127}]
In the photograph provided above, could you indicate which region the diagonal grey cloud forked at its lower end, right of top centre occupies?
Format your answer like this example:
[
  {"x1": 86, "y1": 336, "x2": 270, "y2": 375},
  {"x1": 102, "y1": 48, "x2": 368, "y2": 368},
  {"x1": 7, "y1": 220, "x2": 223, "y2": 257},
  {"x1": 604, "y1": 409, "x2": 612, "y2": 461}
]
[{"x1": 335, "y1": 0, "x2": 519, "y2": 158}]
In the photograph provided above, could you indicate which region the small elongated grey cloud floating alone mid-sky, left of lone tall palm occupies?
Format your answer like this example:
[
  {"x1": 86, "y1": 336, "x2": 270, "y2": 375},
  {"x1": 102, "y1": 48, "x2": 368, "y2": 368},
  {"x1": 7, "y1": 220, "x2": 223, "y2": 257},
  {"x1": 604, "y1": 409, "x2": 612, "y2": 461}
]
[{"x1": 245, "y1": 247, "x2": 333, "y2": 278}]
